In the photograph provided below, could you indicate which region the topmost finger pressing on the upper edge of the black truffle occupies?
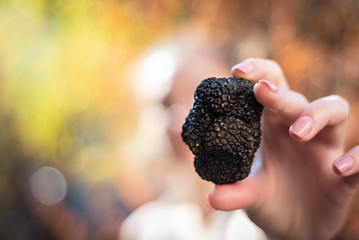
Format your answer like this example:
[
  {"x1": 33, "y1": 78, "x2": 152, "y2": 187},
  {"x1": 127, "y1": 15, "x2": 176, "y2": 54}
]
[{"x1": 232, "y1": 58, "x2": 288, "y2": 88}]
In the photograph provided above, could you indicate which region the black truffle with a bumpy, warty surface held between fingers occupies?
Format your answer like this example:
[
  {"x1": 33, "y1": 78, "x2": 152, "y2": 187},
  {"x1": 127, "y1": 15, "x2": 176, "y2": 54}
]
[{"x1": 182, "y1": 78, "x2": 263, "y2": 184}]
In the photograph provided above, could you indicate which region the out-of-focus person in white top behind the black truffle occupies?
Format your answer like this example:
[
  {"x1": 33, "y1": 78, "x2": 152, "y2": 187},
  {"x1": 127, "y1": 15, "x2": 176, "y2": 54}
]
[{"x1": 120, "y1": 34, "x2": 265, "y2": 240}]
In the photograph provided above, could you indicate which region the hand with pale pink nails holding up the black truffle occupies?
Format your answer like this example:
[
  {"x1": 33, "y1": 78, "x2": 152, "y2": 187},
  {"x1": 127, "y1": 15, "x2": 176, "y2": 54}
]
[{"x1": 207, "y1": 59, "x2": 359, "y2": 240}]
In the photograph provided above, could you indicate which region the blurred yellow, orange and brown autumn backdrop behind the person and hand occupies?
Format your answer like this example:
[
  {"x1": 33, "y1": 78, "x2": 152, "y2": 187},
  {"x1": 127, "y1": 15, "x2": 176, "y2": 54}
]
[{"x1": 0, "y1": 0, "x2": 359, "y2": 239}]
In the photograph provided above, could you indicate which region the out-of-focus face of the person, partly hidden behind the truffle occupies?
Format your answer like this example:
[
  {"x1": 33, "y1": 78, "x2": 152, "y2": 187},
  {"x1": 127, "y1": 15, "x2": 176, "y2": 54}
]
[{"x1": 163, "y1": 56, "x2": 230, "y2": 162}]
